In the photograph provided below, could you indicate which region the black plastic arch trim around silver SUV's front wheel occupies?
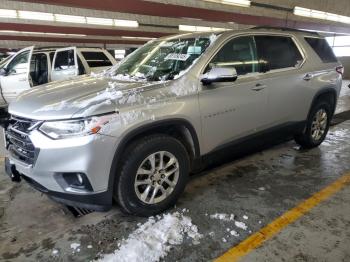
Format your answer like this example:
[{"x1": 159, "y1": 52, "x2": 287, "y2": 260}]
[{"x1": 108, "y1": 118, "x2": 200, "y2": 194}]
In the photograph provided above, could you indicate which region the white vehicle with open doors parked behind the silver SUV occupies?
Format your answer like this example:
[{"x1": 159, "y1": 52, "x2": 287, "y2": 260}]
[{"x1": 0, "y1": 46, "x2": 116, "y2": 107}]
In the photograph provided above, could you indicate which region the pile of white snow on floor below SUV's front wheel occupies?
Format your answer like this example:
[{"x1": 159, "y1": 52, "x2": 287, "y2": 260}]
[{"x1": 100, "y1": 212, "x2": 202, "y2": 262}]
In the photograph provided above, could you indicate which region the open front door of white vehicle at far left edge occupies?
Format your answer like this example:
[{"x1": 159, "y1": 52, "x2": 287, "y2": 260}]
[{"x1": 0, "y1": 46, "x2": 34, "y2": 103}]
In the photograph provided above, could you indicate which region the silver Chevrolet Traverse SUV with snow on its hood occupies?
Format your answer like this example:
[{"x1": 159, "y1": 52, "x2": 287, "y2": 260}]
[{"x1": 6, "y1": 28, "x2": 343, "y2": 216}]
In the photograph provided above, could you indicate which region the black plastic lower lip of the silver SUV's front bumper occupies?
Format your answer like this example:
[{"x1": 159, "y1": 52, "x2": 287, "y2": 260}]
[{"x1": 5, "y1": 158, "x2": 112, "y2": 211}]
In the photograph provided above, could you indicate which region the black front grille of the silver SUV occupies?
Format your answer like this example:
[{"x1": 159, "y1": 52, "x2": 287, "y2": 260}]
[{"x1": 5, "y1": 116, "x2": 39, "y2": 165}]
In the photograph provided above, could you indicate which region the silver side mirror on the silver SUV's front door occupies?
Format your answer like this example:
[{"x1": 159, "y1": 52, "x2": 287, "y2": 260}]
[{"x1": 201, "y1": 67, "x2": 238, "y2": 85}]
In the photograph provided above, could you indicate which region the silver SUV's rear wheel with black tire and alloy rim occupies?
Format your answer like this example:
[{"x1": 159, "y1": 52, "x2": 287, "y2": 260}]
[{"x1": 294, "y1": 100, "x2": 332, "y2": 149}]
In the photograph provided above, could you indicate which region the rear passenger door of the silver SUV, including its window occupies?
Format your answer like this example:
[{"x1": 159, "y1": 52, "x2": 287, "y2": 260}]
[{"x1": 254, "y1": 35, "x2": 309, "y2": 127}]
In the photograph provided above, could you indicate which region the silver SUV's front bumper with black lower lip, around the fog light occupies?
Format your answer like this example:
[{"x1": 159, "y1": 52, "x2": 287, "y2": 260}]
[{"x1": 6, "y1": 130, "x2": 116, "y2": 211}]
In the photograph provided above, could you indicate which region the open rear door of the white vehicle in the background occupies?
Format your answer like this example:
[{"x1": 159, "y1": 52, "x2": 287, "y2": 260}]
[{"x1": 51, "y1": 47, "x2": 79, "y2": 81}]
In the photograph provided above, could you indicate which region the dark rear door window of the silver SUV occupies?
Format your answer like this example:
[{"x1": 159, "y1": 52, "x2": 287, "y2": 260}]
[{"x1": 255, "y1": 36, "x2": 303, "y2": 71}]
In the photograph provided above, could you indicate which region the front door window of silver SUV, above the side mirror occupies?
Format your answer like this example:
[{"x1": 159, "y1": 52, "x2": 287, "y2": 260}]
[{"x1": 205, "y1": 36, "x2": 259, "y2": 75}]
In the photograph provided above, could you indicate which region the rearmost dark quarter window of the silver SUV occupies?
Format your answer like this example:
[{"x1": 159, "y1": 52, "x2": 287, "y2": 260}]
[{"x1": 305, "y1": 37, "x2": 338, "y2": 63}]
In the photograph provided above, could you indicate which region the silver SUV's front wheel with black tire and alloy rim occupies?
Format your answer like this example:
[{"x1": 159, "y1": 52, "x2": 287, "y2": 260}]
[{"x1": 114, "y1": 134, "x2": 190, "y2": 216}]
